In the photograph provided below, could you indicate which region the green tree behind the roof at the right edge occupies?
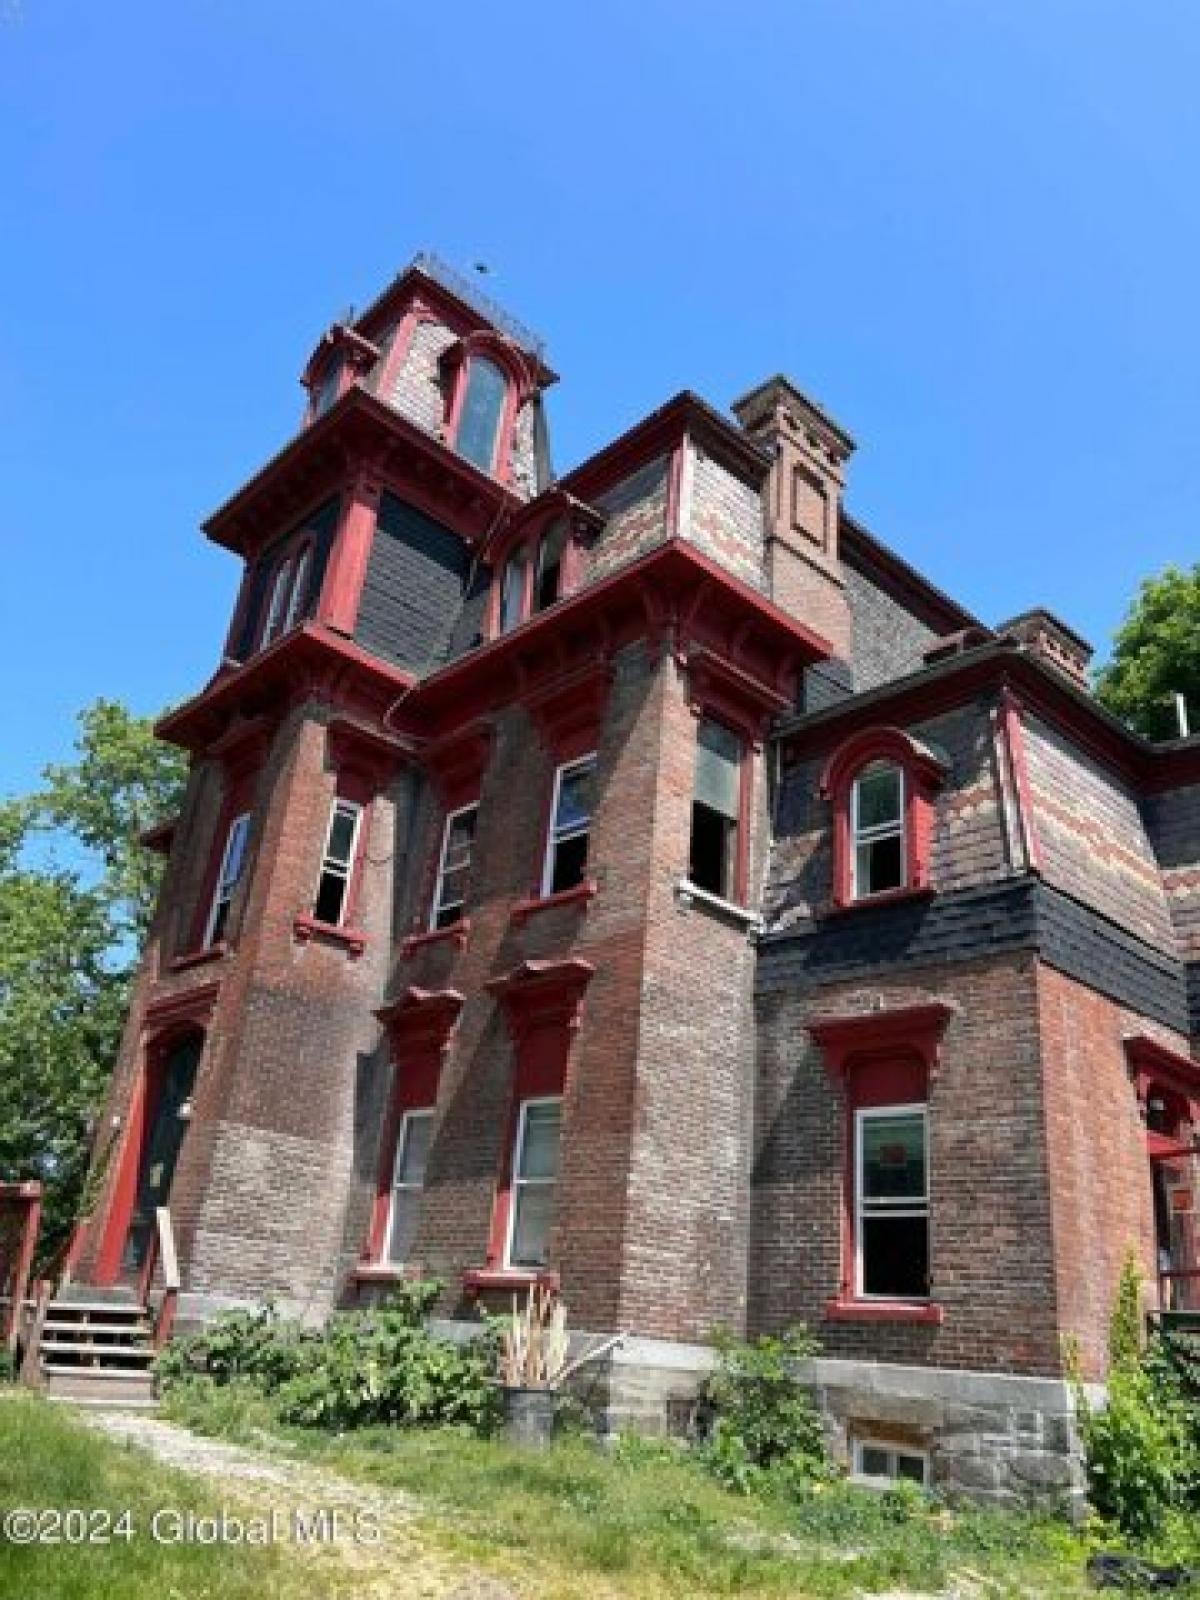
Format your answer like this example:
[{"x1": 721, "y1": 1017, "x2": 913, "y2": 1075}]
[{"x1": 1096, "y1": 562, "x2": 1200, "y2": 739}]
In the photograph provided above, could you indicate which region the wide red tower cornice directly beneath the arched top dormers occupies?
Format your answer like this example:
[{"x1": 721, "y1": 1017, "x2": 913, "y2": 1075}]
[{"x1": 202, "y1": 384, "x2": 522, "y2": 555}]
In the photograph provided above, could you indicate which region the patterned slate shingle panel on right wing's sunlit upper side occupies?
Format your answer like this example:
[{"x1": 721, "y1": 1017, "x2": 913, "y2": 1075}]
[{"x1": 1026, "y1": 715, "x2": 1176, "y2": 954}]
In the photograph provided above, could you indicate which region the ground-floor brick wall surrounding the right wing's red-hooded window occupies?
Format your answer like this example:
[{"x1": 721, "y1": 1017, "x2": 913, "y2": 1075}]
[{"x1": 750, "y1": 955, "x2": 1059, "y2": 1373}]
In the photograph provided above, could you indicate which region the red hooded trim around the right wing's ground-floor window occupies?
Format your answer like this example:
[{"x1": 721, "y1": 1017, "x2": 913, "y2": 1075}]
[{"x1": 808, "y1": 1000, "x2": 955, "y2": 1323}]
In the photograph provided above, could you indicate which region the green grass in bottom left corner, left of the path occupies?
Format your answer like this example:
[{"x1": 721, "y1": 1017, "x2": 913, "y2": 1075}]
[{"x1": 0, "y1": 1389, "x2": 336, "y2": 1600}]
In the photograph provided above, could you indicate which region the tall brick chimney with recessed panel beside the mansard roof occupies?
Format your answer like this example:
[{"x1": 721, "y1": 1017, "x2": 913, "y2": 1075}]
[{"x1": 733, "y1": 376, "x2": 854, "y2": 662}]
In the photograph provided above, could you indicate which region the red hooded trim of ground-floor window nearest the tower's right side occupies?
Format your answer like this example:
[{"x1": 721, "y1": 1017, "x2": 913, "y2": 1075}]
[{"x1": 360, "y1": 986, "x2": 462, "y2": 1266}]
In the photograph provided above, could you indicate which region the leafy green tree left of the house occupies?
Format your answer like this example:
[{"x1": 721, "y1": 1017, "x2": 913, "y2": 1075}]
[{"x1": 0, "y1": 701, "x2": 184, "y2": 1256}]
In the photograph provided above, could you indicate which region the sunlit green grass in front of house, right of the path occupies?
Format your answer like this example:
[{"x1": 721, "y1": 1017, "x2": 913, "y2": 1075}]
[{"x1": 160, "y1": 1387, "x2": 1158, "y2": 1600}]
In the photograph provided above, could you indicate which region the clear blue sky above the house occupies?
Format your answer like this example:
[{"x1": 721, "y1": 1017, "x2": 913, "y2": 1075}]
[{"x1": 0, "y1": 0, "x2": 1200, "y2": 792}]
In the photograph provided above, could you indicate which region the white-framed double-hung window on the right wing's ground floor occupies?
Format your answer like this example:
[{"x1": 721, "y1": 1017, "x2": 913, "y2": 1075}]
[{"x1": 854, "y1": 1106, "x2": 930, "y2": 1299}]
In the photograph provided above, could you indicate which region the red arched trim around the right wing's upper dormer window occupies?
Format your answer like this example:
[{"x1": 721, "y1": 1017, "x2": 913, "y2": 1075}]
[{"x1": 818, "y1": 728, "x2": 946, "y2": 909}]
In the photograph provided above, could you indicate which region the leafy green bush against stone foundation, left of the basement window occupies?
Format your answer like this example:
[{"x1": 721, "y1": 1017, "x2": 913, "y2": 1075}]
[{"x1": 701, "y1": 1328, "x2": 832, "y2": 1494}]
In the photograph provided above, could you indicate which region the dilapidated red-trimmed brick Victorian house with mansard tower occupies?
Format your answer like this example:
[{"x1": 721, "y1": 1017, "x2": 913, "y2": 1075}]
[{"x1": 74, "y1": 259, "x2": 1200, "y2": 1494}]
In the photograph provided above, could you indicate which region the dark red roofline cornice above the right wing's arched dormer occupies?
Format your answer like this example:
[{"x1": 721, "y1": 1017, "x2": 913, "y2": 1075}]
[{"x1": 781, "y1": 642, "x2": 1200, "y2": 792}]
